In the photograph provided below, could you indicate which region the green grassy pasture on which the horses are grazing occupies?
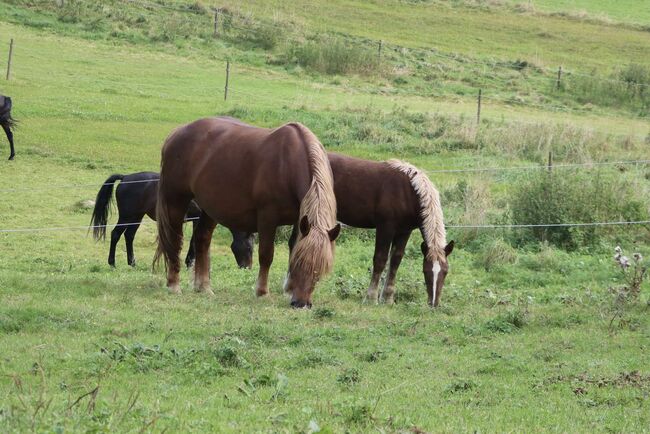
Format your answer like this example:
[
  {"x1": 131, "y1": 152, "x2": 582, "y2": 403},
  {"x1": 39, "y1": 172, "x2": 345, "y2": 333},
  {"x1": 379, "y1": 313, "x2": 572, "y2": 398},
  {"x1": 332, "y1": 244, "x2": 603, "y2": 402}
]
[{"x1": 0, "y1": 0, "x2": 650, "y2": 432}]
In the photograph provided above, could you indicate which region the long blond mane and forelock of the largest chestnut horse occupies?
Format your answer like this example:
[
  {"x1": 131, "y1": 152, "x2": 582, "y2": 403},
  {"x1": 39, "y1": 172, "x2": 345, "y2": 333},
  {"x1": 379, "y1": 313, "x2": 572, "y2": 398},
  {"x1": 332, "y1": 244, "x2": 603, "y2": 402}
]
[{"x1": 289, "y1": 122, "x2": 336, "y2": 278}]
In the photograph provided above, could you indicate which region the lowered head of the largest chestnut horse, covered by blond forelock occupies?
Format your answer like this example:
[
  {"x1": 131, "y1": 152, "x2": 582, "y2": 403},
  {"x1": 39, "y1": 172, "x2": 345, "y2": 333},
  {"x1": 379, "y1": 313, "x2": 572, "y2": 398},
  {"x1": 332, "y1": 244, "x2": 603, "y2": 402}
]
[{"x1": 285, "y1": 216, "x2": 341, "y2": 308}]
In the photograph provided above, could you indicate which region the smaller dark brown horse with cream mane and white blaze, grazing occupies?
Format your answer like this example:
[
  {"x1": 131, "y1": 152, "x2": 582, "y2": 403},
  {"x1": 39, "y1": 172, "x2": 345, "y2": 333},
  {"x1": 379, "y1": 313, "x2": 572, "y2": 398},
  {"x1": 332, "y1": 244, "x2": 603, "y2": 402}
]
[{"x1": 289, "y1": 153, "x2": 454, "y2": 306}]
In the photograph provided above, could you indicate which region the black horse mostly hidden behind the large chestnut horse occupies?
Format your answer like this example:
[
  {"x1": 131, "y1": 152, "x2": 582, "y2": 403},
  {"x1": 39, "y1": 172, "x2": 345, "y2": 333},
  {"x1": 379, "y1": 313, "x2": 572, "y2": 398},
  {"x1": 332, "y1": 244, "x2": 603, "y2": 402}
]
[{"x1": 91, "y1": 172, "x2": 254, "y2": 268}]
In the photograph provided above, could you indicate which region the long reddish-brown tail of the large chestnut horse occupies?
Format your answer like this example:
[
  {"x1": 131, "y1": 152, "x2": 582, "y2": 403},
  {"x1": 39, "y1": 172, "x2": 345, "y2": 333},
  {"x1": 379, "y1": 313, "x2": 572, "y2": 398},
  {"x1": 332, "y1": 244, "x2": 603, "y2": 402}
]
[{"x1": 153, "y1": 128, "x2": 180, "y2": 270}]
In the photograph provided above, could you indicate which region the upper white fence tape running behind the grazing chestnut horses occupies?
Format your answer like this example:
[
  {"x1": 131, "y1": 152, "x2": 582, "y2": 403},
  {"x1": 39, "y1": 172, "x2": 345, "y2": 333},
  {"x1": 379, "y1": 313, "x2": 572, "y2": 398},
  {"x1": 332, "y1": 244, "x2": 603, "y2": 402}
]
[{"x1": 0, "y1": 160, "x2": 650, "y2": 193}]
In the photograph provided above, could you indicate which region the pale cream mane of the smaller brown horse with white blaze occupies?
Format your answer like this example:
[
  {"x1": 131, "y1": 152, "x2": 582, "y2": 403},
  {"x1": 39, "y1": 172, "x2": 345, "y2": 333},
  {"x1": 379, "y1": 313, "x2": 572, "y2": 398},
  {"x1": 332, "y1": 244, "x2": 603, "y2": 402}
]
[{"x1": 388, "y1": 160, "x2": 447, "y2": 261}]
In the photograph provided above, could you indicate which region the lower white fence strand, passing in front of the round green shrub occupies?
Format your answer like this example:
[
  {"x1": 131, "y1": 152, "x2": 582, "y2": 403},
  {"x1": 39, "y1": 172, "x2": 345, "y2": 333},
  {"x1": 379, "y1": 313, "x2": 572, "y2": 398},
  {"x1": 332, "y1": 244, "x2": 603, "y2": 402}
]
[{"x1": 0, "y1": 217, "x2": 650, "y2": 233}]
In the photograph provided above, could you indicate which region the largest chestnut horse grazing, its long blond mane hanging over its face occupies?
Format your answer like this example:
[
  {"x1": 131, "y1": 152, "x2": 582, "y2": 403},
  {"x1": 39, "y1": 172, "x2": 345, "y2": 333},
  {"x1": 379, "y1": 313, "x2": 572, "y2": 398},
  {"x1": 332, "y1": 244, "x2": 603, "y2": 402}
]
[{"x1": 156, "y1": 117, "x2": 340, "y2": 307}]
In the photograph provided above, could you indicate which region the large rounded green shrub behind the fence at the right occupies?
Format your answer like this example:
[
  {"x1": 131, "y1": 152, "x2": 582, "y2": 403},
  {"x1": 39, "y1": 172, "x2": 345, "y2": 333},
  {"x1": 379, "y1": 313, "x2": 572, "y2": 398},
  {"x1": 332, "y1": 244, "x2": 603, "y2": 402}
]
[{"x1": 511, "y1": 172, "x2": 648, "y2": 250}]
